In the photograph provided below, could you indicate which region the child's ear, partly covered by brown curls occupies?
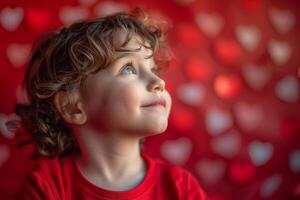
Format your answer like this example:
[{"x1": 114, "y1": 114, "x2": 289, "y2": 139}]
[{"x1": 53, "y1": 91, "x2": 87, "y2": 125}]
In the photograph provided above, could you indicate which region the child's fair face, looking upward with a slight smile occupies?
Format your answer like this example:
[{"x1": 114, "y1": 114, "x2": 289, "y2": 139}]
[{"x1": 84, "y1": 33, "x2": 171, "y2": 136}]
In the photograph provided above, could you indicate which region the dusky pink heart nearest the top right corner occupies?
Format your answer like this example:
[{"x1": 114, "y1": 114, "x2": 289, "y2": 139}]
[{"x1": 269, "y1": 8, "x2": 296, "y2": 34}]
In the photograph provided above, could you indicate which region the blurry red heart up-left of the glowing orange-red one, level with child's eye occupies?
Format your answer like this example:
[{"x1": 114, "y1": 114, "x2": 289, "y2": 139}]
[{"x1": 186, "y1": 58, "x2": 212, "y2": 81}]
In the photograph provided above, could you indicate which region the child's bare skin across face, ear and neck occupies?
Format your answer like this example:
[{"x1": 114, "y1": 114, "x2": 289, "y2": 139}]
[{"x1": 54, "y1": 31, "x2": 171, "y2": 191}]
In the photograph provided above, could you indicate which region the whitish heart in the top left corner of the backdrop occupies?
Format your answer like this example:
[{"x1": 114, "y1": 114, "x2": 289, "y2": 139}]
[{"x1": 0, "y1": 7, "x2": 24, "y2": 31}]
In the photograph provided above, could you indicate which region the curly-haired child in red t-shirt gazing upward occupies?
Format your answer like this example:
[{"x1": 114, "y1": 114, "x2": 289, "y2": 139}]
[{"x1": 16, "y1": 8, "x2": 206, "y2": 200}]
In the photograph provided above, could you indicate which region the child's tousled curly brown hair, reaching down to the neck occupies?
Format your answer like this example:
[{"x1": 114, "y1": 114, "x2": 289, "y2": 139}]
[{"x1": 15, "y1": 9, "x2": 171, "y2": 158}]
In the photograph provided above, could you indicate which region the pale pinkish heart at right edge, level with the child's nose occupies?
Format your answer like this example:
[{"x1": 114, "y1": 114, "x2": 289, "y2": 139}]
[{"x1": 275, "y1": 75, "x2": 299, "y2": 103}]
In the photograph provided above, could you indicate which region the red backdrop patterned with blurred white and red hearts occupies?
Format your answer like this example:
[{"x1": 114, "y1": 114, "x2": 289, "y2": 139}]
[{"x1": 0, "y1": 0, "x2": 300, "y2": 200}]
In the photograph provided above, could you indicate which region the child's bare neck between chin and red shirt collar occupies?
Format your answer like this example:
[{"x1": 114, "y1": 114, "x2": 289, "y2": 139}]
[{"x1": 70, "y1": 127, "x2": 146, "y2": 183}]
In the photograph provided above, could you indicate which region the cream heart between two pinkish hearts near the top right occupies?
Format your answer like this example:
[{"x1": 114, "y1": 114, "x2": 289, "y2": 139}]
[{"x1": 235, "y1": 25, "x2": 261, "y2": 51}]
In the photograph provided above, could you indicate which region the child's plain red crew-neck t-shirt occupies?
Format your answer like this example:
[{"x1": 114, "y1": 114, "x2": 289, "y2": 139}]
[{"x1": 17, "y1": 152, "x2": 207, "y2": 200}]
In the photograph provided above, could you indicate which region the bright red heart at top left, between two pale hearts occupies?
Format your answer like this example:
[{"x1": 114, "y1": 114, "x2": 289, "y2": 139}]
[{"x1": 26, "y1": 8, "x2": 51, "y2": 31}]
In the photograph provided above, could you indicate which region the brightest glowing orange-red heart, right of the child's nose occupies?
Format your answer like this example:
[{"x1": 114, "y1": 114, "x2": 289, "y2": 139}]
[{"x1": 214, "y1": 74, "x2": 242, "y2": 99}]
